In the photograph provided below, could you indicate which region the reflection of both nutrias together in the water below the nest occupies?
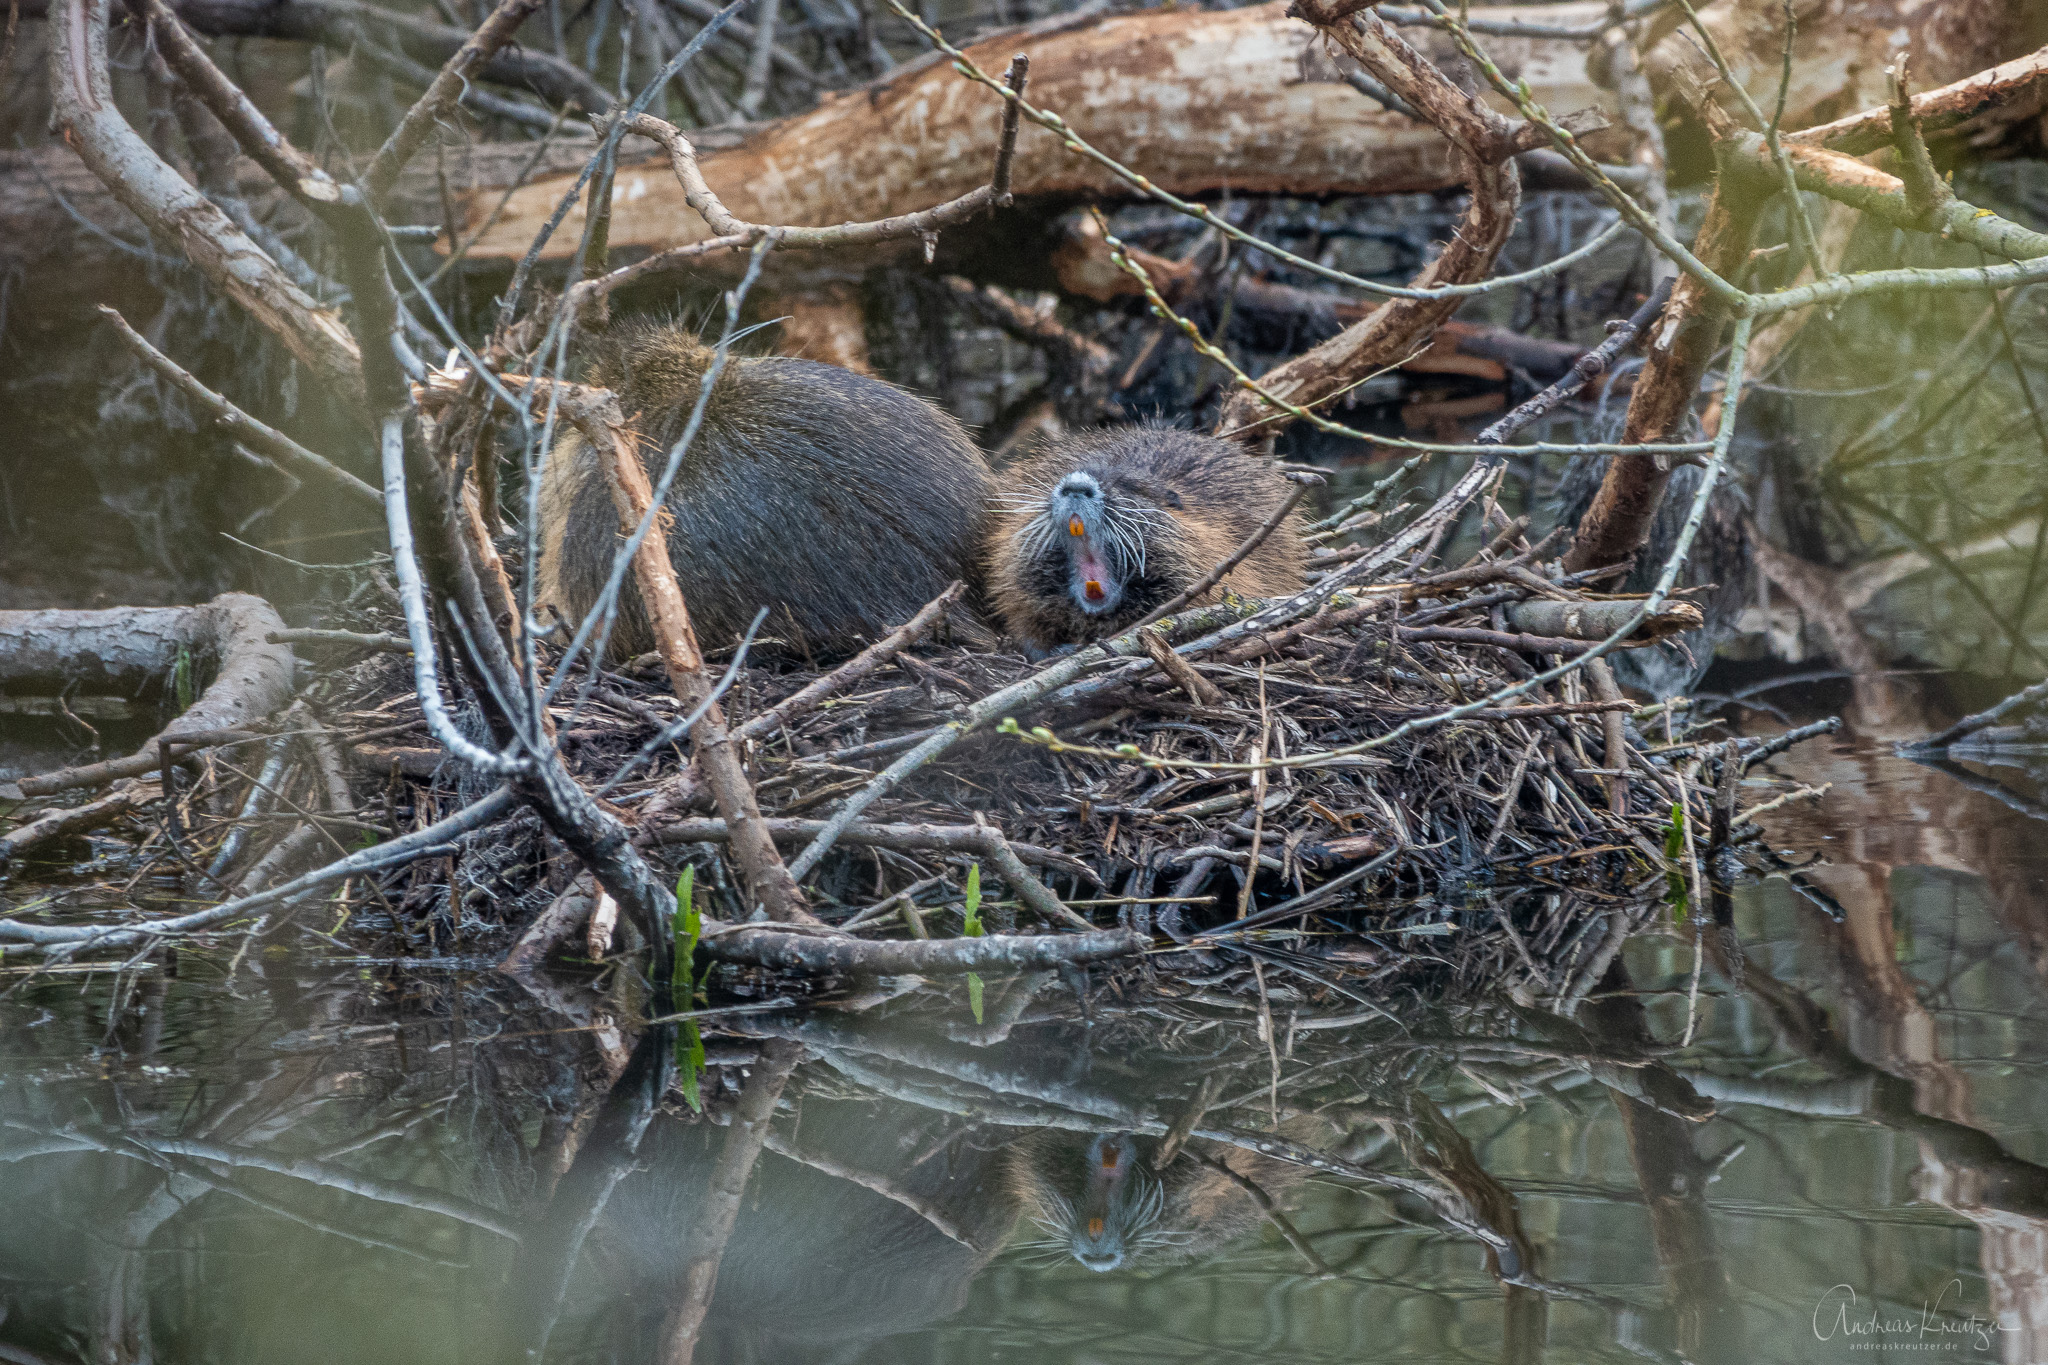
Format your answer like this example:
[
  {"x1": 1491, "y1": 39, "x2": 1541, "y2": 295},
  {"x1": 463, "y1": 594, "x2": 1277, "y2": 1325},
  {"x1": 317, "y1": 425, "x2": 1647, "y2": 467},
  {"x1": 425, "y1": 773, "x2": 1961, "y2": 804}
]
[{"x1": 598, "y1": 1093, "x2": 1327, "y2": 1365}]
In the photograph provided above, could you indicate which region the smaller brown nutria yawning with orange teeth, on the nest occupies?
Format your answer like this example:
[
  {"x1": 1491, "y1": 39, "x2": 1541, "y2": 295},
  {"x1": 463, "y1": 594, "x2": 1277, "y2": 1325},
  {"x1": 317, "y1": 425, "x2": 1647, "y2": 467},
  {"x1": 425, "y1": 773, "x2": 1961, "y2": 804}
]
[{"x1": 989, "y1": 426, "x2": 1305, "y2": 649}]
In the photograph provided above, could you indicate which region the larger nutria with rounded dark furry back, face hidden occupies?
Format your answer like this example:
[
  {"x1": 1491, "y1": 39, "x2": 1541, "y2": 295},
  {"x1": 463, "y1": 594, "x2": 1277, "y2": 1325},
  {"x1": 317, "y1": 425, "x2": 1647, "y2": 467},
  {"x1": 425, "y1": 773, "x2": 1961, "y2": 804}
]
[{"x1": 539, "y1": 323, "x2": 987, "y2": 653}]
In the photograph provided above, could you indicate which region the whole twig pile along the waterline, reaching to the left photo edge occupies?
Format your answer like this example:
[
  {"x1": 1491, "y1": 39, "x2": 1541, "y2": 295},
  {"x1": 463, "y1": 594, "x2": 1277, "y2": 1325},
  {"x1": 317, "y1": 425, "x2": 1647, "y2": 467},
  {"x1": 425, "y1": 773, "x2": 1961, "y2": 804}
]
[{"x1": 0, "y1": 444, "x2": 1851, "y2": 1001}]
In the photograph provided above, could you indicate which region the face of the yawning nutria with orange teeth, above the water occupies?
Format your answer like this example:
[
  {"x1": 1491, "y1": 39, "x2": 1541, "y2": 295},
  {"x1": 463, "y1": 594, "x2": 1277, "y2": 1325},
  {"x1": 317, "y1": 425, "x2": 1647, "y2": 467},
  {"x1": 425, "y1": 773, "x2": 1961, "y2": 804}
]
[{"x1": 1018, "y1": 469, "x2": 1180, "y2": 618}]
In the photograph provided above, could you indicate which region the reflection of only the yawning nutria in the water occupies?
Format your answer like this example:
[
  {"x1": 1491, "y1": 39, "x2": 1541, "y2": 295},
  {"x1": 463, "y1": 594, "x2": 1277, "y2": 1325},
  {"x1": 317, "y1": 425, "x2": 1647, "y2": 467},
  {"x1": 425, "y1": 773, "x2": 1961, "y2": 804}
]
[{"x1": 1008, "y1": 1130, "x2": 1300, "y2": 1271}]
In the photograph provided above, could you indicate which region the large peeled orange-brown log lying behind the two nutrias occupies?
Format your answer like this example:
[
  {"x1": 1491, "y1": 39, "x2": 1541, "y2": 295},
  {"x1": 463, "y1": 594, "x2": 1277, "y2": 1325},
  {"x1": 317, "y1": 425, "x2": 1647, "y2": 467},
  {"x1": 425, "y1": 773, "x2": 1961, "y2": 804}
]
[{"x1": 461, "y1": 0, "x2": 1612, "y2": 258}]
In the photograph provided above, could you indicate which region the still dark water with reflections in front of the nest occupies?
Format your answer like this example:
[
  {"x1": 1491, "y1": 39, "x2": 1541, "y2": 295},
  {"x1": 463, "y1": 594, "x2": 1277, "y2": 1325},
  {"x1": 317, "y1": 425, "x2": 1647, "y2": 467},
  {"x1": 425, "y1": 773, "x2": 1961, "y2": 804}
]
[{"x1": 0, "y1": 698, "x2": 2048, "y2": 1365}]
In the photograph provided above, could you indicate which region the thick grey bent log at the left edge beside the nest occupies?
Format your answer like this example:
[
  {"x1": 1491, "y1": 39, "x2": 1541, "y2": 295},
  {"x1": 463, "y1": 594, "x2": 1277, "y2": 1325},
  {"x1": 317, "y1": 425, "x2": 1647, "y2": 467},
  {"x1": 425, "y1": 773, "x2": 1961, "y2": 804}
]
[{"x1": 0, "y1": 593, "x2": 293, "y2": 796}]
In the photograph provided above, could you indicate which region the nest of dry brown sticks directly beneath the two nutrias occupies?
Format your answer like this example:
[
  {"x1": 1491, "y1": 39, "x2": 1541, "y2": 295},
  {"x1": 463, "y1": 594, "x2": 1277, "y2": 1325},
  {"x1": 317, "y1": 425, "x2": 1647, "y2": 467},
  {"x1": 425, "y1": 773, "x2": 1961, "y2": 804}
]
[{"x1": 268, "y1": 470, "x2": 1826, "y2": 999}]
